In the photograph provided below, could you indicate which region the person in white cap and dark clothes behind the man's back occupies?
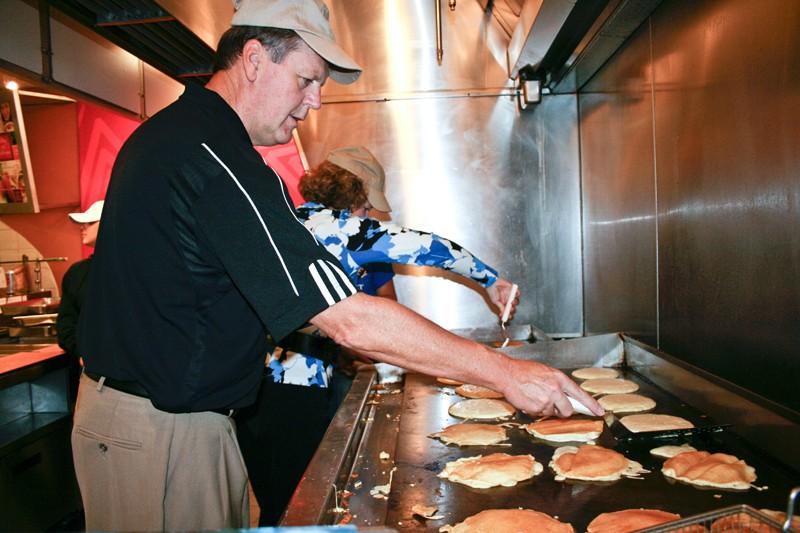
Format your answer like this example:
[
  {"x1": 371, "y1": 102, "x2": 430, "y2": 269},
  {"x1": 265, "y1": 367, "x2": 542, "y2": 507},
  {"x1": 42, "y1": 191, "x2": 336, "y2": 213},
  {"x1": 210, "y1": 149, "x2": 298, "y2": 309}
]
[{"x1": 56, "y1": 200, "x2": 103, "y2": 404}]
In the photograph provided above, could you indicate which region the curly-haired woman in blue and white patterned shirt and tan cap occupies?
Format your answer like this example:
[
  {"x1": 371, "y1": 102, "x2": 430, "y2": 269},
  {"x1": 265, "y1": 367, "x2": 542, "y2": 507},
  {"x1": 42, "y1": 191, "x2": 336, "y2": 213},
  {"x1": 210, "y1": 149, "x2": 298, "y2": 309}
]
[{"x1": 237, "y1": 146, "x2": 516, "y2": 527}]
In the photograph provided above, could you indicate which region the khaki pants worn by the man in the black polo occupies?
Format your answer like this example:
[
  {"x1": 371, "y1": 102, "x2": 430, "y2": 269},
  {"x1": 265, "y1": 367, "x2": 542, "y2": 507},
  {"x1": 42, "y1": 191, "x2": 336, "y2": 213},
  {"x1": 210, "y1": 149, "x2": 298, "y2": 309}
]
[{"x1": 72, "y1": 376, "x2": 249, "y2": 531}]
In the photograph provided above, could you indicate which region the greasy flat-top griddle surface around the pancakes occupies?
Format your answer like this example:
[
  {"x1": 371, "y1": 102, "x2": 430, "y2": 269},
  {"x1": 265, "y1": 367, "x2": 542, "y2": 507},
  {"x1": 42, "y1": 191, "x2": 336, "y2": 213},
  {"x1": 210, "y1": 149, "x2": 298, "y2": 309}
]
[{"x1": 334, "y1": 369, "x2": 800, "y2": 531}]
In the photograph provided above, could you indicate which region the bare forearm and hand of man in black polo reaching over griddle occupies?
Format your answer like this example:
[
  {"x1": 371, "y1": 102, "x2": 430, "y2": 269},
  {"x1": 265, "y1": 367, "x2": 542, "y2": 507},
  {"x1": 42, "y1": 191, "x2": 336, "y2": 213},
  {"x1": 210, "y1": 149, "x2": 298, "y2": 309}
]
[{"x1": 311, "y1": 293, "x2": 603, "y2": 416}]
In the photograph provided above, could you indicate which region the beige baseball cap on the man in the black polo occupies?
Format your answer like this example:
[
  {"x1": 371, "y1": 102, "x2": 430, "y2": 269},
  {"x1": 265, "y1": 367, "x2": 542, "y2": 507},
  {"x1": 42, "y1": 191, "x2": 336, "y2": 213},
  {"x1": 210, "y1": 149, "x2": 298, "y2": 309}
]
[{"x1": 231, "y1": 0, "x2": 361, "y2": 84}]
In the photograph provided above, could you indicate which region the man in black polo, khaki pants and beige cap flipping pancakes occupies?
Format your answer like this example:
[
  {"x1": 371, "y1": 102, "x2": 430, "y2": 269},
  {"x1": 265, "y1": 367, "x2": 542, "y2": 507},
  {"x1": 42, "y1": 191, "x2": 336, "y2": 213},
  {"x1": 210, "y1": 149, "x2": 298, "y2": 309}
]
[{"x1": 72, "y1": 0, "x2": 602, "y2": 531}]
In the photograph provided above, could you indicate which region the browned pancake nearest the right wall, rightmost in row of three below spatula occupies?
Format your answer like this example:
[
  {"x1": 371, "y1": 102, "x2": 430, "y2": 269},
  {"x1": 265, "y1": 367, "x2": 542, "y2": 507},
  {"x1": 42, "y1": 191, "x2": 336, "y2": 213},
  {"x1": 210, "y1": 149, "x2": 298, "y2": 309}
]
[{"x1": 661, "y1": 452, "x2": 756, "y2": 490}]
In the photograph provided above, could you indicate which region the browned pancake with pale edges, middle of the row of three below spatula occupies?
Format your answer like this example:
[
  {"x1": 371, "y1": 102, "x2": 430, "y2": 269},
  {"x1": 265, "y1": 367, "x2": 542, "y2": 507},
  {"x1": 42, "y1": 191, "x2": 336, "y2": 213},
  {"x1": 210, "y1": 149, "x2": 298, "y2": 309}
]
[{"x1": 550, "y1": 444, "x2": 647, "y2": 481}]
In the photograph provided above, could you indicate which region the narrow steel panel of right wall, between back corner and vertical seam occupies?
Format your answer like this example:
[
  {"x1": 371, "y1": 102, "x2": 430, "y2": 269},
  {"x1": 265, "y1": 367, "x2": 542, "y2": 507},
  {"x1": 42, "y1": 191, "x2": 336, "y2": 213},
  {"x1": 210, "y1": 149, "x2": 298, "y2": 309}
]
[{"x1": 580, "y1": 18, "x2": 657, "y2": 343}]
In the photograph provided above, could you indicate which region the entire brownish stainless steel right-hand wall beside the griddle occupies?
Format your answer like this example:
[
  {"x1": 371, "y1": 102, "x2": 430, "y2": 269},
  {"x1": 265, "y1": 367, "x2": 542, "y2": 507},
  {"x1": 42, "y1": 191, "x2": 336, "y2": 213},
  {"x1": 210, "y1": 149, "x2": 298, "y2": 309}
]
[{"x1": 579, "y1": 0, "x2": 800, "y2": 410}]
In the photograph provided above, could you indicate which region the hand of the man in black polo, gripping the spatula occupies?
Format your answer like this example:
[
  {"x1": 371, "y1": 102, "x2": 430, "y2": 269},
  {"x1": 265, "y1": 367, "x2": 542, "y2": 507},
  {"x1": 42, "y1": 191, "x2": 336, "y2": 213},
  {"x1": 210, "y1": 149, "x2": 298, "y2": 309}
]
[{"x1": 502, "y1": 359, "x2": 605, "y2": 417}]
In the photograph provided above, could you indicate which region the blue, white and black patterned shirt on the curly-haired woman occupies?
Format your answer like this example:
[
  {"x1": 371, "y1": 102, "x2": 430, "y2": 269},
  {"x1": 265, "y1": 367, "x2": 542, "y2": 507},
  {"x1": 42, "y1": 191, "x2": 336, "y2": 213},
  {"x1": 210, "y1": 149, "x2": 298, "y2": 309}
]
[{"x1": 267, "y1": 202, "x2": 497, "y2": 387}]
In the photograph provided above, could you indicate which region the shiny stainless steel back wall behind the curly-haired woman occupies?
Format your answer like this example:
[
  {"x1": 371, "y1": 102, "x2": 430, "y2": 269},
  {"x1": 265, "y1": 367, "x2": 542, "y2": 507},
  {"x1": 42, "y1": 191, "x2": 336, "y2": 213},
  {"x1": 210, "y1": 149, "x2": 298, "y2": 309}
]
[{"x1": 299, "y1": 0, "x2": 582, "y2": 335}]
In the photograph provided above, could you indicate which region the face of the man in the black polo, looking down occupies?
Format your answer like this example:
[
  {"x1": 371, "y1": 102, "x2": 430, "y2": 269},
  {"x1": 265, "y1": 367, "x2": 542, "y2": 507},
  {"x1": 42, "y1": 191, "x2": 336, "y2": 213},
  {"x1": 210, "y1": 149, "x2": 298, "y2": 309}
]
[{"x1": 246, "y1": 42, "x2": 328, "y2": 146}]
